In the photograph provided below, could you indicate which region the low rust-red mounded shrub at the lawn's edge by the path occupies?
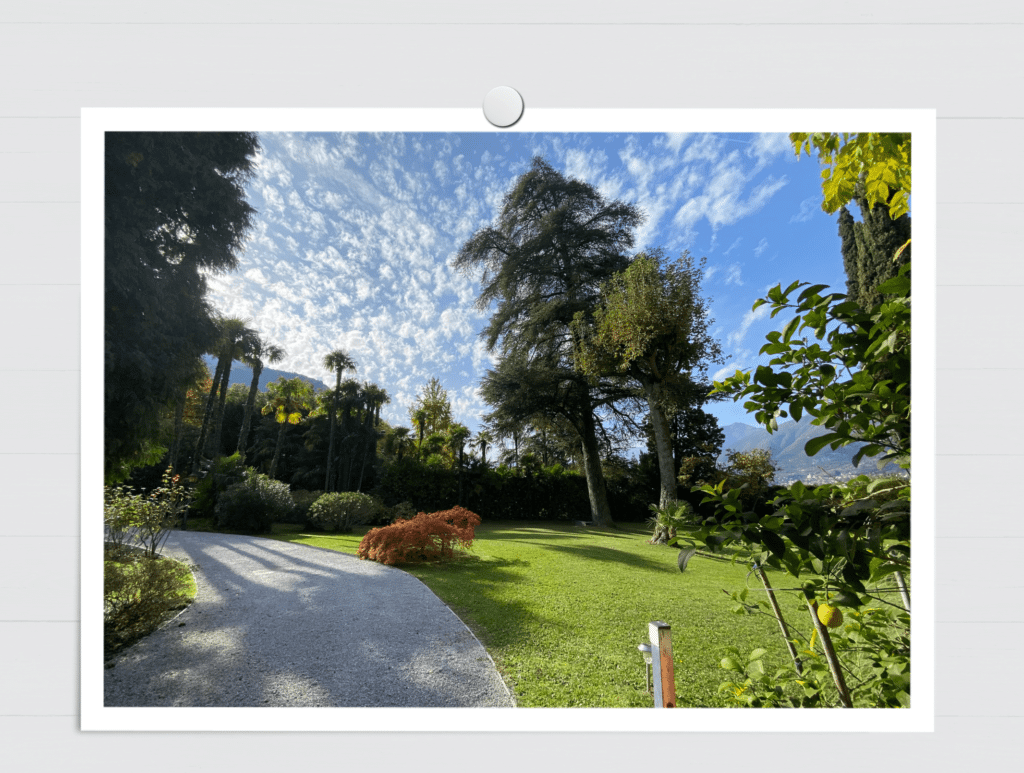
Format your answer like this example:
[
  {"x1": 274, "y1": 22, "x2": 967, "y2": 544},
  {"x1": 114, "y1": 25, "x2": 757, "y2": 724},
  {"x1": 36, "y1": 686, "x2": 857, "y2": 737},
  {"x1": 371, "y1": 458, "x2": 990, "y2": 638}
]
[{"x1": 356, "y1": 507, "x2": 480, "y2": 566}]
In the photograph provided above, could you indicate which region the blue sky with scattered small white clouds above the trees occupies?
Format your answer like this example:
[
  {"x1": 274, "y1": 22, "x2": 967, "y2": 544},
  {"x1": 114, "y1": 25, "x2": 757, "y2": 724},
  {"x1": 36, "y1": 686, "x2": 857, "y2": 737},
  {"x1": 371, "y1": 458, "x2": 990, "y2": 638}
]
[{"x1": 203, "y1": 127, "x2": 859, "y2": 444}]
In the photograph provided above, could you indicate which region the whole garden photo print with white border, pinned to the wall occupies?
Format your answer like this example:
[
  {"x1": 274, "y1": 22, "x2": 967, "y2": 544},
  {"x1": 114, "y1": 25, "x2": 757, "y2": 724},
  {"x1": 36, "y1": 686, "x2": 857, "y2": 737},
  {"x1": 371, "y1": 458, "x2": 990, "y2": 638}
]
[{"x1": 82, "y1": 111, "x2": 934, "y2": 730}]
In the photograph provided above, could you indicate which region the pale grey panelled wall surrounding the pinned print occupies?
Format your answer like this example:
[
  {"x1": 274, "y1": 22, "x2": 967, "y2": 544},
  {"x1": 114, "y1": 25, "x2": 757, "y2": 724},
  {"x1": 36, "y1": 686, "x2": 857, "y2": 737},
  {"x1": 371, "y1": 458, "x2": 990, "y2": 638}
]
[{"x1": 0, "y1": 0, "x2": 1024, "y2": 772}]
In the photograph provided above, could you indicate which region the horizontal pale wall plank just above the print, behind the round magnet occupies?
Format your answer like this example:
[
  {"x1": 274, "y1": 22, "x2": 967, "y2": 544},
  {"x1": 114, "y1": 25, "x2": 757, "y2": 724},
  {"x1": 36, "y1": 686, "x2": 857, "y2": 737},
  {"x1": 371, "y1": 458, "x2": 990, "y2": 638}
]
[{"x1": 0, "y1": 24, "x2": 1024, "y2": 116}]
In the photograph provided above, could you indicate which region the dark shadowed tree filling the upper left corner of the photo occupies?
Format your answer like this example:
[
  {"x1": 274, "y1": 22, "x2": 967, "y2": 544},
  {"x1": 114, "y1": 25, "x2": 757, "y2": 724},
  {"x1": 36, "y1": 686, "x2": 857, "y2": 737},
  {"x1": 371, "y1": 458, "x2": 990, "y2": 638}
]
[{"x1": 104, "y1": 132, "x2": 259, "y2": 479}]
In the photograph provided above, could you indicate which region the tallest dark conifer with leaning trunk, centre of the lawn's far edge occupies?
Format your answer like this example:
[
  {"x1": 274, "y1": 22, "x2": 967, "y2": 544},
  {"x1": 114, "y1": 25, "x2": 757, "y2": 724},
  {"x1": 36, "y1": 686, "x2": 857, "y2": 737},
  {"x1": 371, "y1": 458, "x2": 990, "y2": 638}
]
[{"x1": 454, "y1": 158, "x2": 643, "y2": 525}]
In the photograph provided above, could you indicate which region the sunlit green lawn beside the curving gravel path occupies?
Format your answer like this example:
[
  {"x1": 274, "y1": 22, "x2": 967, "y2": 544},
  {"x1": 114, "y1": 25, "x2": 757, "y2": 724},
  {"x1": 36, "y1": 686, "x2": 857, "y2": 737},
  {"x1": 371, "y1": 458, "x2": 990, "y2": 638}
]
[{"x1": 270, "y1": 523, "x2": 808, "y2": 707}]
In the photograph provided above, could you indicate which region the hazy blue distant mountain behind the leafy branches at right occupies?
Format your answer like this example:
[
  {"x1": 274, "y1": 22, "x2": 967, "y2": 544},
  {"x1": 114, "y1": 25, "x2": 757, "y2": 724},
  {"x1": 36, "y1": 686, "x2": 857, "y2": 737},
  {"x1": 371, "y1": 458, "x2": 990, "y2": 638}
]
[{"x1": 719, "y1": 416, "x2": 900, "y2": 483}]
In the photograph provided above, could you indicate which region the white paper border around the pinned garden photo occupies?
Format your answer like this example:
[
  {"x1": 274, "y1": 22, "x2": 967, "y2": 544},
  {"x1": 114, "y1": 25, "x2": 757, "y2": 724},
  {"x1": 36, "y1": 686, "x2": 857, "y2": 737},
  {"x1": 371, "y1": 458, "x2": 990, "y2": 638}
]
[{"x1": 81, "y1": 105, "x2": 936, "y2": 733}]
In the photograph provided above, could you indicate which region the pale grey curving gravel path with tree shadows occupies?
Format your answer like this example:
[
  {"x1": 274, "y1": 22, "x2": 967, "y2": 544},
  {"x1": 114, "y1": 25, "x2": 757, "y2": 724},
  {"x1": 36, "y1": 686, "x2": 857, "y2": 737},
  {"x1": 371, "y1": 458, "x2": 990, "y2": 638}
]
[{"x1": 104, "y1": 531, "x2": 514, "y2": 706}]
